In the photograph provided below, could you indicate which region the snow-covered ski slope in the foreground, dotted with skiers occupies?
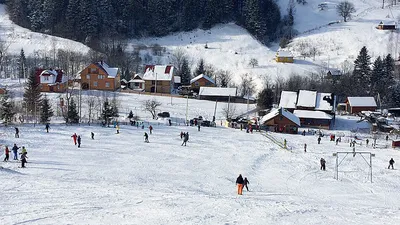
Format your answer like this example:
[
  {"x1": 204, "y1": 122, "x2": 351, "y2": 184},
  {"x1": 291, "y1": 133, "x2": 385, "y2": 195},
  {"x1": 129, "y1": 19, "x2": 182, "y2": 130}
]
[{"x1": 0, "y1": 115, "x2": 400, "y2": 225}]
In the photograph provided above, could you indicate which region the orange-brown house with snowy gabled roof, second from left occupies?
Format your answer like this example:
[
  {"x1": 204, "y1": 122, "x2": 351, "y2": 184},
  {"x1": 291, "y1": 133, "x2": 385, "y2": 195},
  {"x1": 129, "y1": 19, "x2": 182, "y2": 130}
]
[{"x1": 79, "y1": 61, "x2": 121, "y2": 91}]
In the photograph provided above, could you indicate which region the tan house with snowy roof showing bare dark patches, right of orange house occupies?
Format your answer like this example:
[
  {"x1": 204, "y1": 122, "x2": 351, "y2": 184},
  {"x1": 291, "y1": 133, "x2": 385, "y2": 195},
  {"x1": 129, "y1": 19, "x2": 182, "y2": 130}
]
[{"x1": 143, "y1": 65, "x2": 174, "y2": 94}]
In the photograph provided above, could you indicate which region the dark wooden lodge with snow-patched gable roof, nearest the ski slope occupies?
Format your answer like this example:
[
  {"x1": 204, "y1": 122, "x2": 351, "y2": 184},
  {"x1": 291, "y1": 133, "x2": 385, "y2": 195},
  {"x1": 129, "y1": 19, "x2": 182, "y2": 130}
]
[{"x1": 260, "y1": 107, "x2": 300, "y2": 134}]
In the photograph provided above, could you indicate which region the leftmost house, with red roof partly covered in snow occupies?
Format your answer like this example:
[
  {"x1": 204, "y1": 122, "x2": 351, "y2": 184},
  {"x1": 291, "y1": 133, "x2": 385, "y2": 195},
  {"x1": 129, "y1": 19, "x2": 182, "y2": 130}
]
[{"x1": 35, "y1": 68, "x2": 68, "y2": 93}]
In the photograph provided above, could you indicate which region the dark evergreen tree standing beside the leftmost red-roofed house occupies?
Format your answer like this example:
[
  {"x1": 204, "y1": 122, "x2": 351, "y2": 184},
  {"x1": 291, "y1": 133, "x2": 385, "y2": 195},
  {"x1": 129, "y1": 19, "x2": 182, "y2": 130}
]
[{"x1": 24, "y1": 68, "x2": 42, "y2": 114}]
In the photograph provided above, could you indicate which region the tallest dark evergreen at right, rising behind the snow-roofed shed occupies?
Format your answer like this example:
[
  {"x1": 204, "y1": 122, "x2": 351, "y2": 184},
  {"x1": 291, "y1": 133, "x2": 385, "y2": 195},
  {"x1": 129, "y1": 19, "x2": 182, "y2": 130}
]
[{"x1": 353, "y1": 46, "x2": 371, "y2": 95}]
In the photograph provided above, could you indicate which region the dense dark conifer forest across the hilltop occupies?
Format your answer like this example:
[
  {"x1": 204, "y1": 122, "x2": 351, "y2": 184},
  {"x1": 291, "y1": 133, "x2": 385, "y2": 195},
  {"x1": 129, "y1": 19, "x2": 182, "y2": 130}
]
[{"x1": 3, "y1": 0, "x2": 283, "y2": 45}]
